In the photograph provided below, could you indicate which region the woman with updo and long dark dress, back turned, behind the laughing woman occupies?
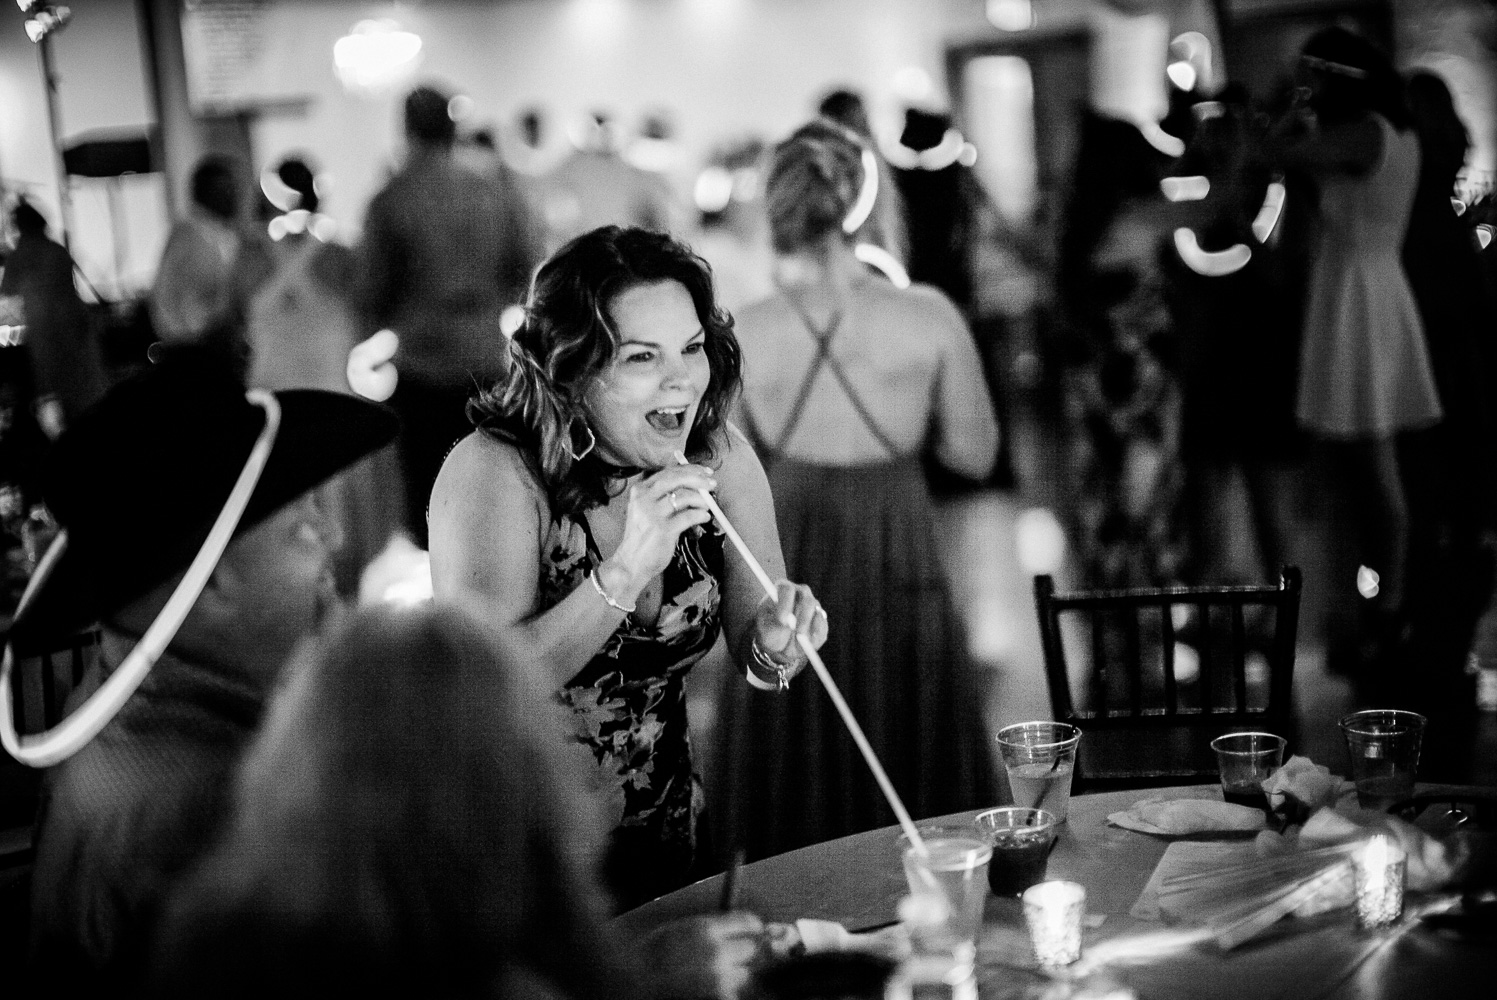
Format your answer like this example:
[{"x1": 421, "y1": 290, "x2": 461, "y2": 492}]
[{"x1": 725, "y1": 120, "x2": 998, "y2": 856}]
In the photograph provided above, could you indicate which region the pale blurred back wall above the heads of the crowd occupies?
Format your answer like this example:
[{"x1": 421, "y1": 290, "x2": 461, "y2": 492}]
[{"x1": 0, "y1": 0, "x2": 1497, "y2": 296}]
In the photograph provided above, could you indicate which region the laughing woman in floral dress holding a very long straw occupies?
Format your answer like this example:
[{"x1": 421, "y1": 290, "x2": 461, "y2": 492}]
[{"x1": 430, "y1": 226, "x2": 826, "y2": 909}]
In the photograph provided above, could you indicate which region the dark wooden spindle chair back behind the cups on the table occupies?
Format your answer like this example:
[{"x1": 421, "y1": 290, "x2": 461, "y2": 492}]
[{"x1": 1034, "y1": 566, "x2": 1301, "y2": 790}]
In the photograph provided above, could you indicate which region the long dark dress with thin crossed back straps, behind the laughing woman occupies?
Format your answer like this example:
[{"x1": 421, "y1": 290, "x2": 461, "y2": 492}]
[{"x1": 719, "y1": 299, "x2": 997, "y2": 859}]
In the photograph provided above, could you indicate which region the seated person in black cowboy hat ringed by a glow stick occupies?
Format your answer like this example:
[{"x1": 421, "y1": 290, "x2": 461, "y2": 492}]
[{"x1": 0, "y1": 352, "x2": 395, "y2": 990}]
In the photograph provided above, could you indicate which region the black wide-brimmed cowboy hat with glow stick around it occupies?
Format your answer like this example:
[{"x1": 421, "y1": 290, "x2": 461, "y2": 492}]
[{"x1": 10, "y1": 353, "x2": 398, "y2": 648}]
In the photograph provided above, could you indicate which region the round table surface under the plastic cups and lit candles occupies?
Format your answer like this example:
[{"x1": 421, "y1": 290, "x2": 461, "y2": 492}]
[{"x1": 615, "y1": 786, "x2": 1497, "y2": 1000}]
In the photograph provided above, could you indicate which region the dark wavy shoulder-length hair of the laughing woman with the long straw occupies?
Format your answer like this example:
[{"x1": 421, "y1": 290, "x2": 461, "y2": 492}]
[{"x1": 467, "y1": 226, "x2": 743, "y2": 515}]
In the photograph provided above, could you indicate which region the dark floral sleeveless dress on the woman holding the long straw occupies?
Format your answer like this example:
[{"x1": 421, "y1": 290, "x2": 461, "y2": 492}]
[{"x1": 539, "y1": 515, "x2": 723, "y2": 909}]
